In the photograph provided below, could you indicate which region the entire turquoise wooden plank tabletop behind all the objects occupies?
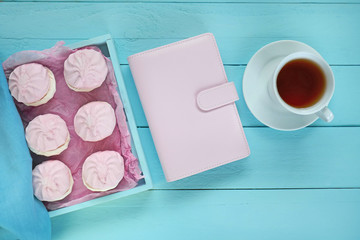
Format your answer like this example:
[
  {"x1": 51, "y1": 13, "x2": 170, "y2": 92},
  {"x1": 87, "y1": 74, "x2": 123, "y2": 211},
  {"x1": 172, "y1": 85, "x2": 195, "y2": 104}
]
[{"x1": 0, "y1": 0, "x2": 360, "y2": 240}]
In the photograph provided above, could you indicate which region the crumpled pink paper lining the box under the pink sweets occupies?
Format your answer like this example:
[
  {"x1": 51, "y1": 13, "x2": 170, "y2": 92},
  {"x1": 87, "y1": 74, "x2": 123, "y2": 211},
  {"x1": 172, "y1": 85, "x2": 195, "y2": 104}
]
[{"x1": 3, "y1": 42, "x2": 143, "y2": 210}]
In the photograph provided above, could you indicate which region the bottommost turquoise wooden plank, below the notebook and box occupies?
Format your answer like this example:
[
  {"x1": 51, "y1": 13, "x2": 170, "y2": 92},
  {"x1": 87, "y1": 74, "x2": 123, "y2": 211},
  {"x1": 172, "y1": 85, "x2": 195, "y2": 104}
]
[{"x1": 52, "y1": 189, "x2": 360, "y2": 240}]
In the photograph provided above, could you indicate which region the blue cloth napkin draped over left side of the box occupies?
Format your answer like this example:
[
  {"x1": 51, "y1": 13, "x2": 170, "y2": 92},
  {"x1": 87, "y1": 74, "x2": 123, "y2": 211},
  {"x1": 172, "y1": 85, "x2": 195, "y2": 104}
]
[{"x1": 0, "y1": 63, "x2": 51, "y2": 240}]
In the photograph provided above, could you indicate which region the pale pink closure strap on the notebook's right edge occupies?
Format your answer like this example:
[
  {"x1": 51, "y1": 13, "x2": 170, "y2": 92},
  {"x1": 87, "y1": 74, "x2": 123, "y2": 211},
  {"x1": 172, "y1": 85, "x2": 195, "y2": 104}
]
[{"x1": 196, "y1": 82, "x2": 239, "y2": 111}]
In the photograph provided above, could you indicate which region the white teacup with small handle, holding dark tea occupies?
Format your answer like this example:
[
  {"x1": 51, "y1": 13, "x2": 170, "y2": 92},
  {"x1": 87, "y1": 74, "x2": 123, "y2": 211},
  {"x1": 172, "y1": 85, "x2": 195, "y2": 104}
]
[{"x1": 268, "y1": 52, "x2": 335, "y2": 122}]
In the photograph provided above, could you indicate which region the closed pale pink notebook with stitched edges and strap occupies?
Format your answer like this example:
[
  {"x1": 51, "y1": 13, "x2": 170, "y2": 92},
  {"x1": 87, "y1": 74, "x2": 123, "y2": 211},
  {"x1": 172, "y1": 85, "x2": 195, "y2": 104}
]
[{"x1": 128, "y1": 33, "x2": 250, "y2": 182}]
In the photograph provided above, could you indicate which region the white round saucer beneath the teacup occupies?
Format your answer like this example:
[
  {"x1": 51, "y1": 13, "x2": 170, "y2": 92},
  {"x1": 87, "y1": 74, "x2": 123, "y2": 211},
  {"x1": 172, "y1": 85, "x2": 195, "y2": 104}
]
[{"x1": 243, "y1": 40, "x2": 320, "y2": 131}]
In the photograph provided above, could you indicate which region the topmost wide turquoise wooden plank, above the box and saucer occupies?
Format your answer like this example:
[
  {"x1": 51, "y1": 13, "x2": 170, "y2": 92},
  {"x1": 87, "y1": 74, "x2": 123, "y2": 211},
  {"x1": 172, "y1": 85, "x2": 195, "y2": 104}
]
[{"x1": 0, "y1": 3, "x2": 360, "y2": 64}]
